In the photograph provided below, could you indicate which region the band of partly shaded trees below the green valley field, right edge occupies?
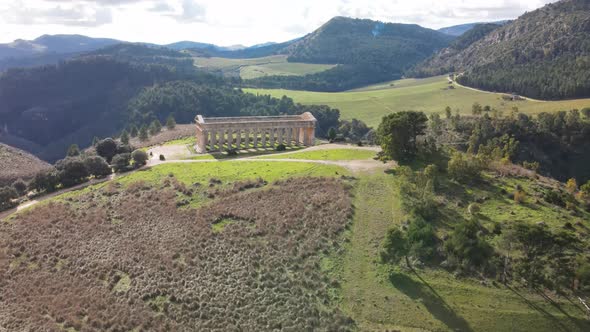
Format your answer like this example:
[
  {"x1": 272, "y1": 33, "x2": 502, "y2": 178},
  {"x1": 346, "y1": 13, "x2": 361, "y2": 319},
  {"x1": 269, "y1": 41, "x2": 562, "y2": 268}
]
[{"x1": 446, "y1": 107, "x2": 590, "y2": 182}]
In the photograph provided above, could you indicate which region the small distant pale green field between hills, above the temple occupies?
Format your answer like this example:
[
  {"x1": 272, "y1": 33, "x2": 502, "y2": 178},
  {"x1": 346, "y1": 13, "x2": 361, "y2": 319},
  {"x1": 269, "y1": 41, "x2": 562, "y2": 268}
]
[{"x1": 194, "y1": 55, "x2": 334, "y2": 79}]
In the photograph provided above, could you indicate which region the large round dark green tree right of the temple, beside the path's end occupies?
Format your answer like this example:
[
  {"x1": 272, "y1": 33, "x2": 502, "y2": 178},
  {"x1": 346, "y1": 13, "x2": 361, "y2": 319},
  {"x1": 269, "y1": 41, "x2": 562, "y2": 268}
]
[{"x1": 377, "y1": 111, "x2": 428, "y2": 160}]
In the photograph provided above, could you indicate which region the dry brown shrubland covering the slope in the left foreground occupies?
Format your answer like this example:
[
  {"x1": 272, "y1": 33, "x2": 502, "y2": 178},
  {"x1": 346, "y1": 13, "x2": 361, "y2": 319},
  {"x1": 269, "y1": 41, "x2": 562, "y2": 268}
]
[{"x1": 0, "y1": 178, "x2": 352, "y2": 331}]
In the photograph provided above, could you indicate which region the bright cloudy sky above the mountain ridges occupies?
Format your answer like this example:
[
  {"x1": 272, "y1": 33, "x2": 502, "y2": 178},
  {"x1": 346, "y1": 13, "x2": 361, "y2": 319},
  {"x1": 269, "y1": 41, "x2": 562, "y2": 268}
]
[{"x1": 0, "y1": 0, "x2": 555, "y2": 46}]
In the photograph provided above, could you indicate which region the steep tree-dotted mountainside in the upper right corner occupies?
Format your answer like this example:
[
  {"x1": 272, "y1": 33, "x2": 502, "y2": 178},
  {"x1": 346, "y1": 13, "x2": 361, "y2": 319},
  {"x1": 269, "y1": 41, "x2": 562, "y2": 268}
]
[{"x1": 416, "y1": 0, "x2": 590, "y2": 99}]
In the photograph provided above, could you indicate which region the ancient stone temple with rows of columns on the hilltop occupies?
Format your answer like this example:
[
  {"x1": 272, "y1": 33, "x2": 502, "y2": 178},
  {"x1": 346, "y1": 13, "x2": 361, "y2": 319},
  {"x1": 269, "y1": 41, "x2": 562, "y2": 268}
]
[{"x1": 195, "y1": 112, "x2": 317, "y2": 153}]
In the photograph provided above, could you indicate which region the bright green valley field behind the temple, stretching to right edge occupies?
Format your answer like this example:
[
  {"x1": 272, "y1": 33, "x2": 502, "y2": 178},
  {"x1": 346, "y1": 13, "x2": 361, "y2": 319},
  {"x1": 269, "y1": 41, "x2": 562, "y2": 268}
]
[{"x1": 245, "y1": 76, "x2": 590, "y2": 127}]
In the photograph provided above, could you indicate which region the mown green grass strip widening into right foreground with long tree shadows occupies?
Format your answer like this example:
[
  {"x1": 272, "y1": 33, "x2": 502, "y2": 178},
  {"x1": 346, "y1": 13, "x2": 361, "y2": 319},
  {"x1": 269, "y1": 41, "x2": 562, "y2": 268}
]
[{"x1": 326, "y1": 174, "x2": 584, "y2": 331}]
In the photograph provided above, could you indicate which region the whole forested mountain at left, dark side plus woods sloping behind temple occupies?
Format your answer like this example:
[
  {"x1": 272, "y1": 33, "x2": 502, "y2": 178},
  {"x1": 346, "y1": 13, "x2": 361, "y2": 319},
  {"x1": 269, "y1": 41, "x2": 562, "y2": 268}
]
[{"x1": 0, "y1": 44, "x2": 339, "y2": 161}]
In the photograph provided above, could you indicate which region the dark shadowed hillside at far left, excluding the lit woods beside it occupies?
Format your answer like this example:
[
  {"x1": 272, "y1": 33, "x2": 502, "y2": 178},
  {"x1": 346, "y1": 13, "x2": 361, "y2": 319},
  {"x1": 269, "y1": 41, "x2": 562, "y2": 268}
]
[{"x1": 0, "y1": 56, "x2": 190, "y2": 160}]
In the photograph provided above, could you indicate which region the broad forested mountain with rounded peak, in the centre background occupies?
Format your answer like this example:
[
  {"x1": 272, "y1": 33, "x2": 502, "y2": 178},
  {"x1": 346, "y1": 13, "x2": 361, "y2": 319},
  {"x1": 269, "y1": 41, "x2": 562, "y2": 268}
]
[{"x1": 247, "y1": 17, "x2": 453, "y2": 91}]
